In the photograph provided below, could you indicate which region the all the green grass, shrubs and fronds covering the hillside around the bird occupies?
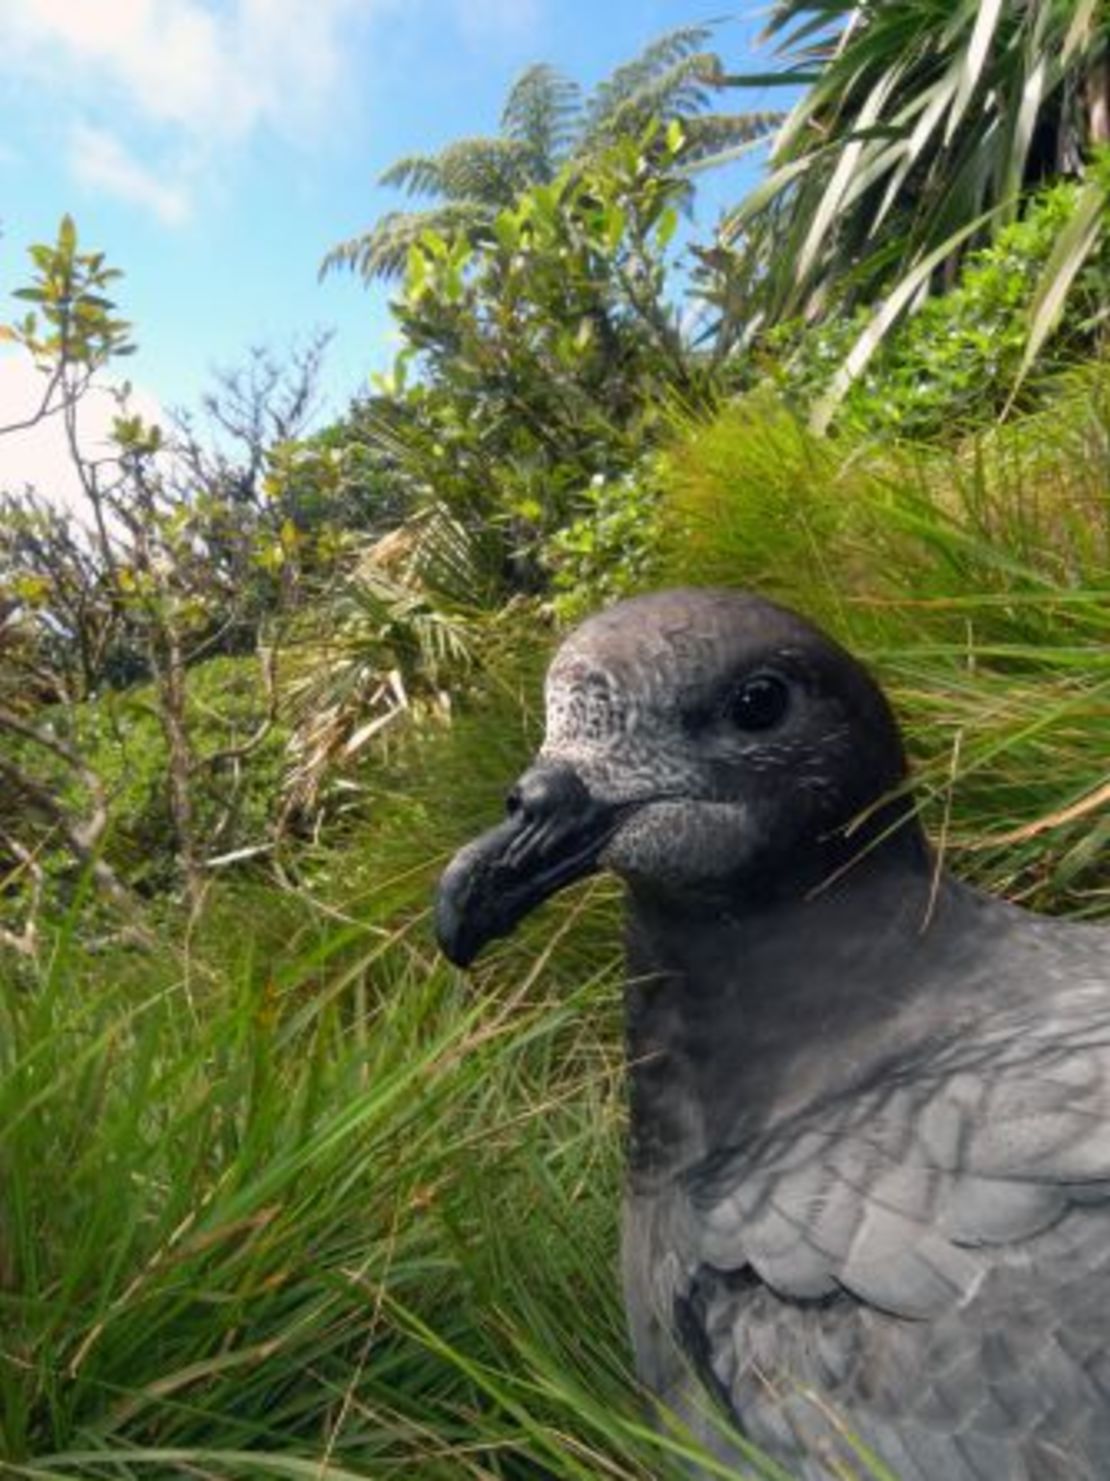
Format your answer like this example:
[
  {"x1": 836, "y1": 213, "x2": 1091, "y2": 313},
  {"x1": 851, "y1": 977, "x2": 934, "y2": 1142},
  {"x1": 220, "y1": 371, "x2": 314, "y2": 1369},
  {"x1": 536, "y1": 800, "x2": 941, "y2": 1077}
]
[{"x1": 0, "y1": 11, "x2": 1110, "y2": 1481}]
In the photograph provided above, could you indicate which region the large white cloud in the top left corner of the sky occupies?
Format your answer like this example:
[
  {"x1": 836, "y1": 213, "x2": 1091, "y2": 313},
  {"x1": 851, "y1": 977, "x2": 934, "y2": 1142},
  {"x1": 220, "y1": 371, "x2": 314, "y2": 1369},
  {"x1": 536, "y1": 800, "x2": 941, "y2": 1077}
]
[{"x1": 0, "y1": 0, "x2": 370, "y2": 225}]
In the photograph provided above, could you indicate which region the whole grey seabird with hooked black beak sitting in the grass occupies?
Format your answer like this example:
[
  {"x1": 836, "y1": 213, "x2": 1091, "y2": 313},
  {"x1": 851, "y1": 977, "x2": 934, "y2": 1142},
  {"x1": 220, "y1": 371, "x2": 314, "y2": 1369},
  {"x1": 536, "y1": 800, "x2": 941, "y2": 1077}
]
[{"x1": 437, "y1": 589, "x2": 1110, "y2": 1481}]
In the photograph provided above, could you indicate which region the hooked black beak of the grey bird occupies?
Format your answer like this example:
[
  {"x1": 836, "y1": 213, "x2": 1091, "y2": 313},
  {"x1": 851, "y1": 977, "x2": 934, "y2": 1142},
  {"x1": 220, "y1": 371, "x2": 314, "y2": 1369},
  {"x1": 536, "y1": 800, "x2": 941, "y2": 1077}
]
[{"x1": 436, "y1": 761, "x2": 618, "y2": 967}]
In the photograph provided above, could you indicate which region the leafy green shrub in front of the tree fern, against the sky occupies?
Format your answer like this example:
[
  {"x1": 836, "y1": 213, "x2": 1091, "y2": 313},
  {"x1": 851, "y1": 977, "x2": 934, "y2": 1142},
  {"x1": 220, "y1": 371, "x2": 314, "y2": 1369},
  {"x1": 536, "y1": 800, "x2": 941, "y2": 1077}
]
[{"x1": 357, "y1": 124, "x2": 713, "y2": 589}]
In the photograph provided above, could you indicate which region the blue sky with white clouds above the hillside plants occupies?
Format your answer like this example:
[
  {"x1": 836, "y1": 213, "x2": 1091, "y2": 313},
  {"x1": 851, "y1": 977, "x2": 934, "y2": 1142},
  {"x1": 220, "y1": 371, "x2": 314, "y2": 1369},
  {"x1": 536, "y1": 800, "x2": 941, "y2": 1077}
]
[{"x1": 0, "y1": 0, "x2": 778, "y2": 459}]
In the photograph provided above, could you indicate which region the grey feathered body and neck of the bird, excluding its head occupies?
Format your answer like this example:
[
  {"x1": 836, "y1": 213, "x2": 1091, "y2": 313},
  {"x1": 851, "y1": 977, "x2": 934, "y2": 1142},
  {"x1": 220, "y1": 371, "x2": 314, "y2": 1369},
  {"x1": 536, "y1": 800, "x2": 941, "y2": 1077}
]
[{"x1": 624, "y1": 877, "x2": 1110, "y2": 1481}]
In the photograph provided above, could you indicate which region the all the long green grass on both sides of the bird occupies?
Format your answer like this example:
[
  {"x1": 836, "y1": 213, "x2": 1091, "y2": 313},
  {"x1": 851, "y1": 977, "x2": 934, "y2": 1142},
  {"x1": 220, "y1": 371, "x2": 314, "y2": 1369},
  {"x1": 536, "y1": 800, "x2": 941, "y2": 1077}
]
[{"x1": 0, "y1": 376, "x2": 1110, "y2": 1481}]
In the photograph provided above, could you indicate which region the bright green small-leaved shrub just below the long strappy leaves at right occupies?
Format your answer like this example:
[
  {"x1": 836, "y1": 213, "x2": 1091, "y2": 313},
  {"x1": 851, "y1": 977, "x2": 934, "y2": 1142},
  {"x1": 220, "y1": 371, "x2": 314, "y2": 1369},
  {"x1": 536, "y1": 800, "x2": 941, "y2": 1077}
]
[{"x1": 768, "y1": 182, "x2": 1110, "y2": 440}]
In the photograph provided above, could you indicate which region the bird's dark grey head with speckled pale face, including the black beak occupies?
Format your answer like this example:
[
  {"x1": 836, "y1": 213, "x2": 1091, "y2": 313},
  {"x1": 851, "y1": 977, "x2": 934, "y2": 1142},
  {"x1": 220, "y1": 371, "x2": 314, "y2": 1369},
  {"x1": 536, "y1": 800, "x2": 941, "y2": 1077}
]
[{"x1": 436, "y1": 588, "x2": 919, "y2": 966}]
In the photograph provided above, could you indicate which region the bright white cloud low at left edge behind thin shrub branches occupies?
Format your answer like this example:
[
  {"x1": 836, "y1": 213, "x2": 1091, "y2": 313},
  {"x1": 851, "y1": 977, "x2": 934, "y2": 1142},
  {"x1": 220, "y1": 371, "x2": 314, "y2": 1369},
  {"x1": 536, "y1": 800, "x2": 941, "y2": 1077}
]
[{"x1": 0, "y1": 352, "x2": 164, "y2": 514}]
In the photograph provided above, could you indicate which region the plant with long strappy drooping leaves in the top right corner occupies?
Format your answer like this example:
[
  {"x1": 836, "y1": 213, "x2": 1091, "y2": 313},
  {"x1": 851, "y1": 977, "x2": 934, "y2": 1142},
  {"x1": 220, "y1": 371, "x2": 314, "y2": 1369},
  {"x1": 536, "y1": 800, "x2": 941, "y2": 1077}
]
[{"x1": 731, "y1": 0, "x2": 1110, "y2": 415}]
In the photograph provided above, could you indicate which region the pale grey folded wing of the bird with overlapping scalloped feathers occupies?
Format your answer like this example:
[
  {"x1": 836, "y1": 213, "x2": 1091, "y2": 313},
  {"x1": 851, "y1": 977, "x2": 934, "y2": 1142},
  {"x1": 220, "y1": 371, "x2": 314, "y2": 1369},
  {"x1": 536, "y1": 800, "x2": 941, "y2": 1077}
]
[{"x1": 657, "y1": 1012, "x2": 1110, "y2": 1481}]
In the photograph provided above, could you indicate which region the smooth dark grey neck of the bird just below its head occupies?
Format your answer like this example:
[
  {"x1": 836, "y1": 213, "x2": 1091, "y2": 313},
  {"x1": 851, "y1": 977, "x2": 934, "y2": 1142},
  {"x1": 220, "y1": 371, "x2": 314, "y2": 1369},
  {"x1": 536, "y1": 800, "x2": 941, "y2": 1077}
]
[{"x1": 625, "y1": 844, "x2": 966, "y2": 1182}]
